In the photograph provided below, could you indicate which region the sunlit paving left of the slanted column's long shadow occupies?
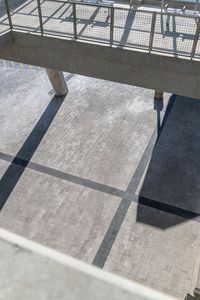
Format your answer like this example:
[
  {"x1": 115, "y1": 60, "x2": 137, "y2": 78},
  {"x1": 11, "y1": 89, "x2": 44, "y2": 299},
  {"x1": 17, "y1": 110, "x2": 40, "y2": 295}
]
[{"x1": 0, "y1": 61, "x2": 52, "y2": 156}]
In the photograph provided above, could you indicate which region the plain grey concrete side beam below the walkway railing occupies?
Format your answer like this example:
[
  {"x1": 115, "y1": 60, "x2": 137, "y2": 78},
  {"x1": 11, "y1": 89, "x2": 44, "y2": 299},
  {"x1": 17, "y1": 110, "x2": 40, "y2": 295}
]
[{"x1": 0, "y1": 32, "x2": 200, "y2": 98}]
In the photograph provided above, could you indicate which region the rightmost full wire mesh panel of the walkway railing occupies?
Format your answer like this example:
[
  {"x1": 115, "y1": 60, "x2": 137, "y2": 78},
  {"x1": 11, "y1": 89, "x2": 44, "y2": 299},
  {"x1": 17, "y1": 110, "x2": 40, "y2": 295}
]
[{"x1": 153, "y1": 14, "x2": 196, "y2": 56}]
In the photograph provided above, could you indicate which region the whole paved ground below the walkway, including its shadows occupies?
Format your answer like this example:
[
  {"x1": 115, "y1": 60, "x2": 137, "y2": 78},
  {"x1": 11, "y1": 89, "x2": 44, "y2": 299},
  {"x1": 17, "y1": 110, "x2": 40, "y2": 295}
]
[{"x1": 0, "y1": 61, "x2": 200, "y2": 299}]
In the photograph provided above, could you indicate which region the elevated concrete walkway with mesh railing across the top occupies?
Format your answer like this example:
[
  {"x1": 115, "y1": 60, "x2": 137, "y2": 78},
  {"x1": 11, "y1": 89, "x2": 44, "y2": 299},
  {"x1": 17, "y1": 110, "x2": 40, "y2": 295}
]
[{"x1": 0, "y1": 0, "x2": 200, "y2": 98}]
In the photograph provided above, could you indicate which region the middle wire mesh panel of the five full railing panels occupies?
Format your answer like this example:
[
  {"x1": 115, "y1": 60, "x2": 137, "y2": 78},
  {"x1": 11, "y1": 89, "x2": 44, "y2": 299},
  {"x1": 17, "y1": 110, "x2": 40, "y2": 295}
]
[{"x1": 76, "y1": 4, "x2": 110, "y2": 43}]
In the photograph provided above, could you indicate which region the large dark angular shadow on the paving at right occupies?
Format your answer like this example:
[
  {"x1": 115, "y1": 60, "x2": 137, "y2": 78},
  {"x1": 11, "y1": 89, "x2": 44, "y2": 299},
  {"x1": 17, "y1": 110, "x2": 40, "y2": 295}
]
[{"x1": 137, "y1": 96, "x2": 200, "y2": 229}]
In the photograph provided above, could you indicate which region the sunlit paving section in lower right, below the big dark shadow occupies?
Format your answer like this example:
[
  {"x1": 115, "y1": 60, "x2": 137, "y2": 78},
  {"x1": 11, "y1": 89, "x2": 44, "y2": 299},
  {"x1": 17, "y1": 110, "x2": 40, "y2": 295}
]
[{"x1": 104, "y1": 203, "x2": 200, "y2": 299}]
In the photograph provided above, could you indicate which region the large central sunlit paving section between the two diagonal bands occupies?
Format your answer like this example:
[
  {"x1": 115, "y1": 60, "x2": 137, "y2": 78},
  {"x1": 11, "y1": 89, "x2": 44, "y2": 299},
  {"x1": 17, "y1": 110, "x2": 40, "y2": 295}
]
[{"x1": 30, "y1": 76, "x2": 156, "y2": 189}]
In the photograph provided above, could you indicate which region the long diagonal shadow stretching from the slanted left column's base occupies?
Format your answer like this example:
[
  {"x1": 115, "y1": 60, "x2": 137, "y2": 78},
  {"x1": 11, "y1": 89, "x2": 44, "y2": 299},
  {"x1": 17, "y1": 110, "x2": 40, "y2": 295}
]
[{"x1": 0, "y1": 96, "x2": 65, "y2": 210}]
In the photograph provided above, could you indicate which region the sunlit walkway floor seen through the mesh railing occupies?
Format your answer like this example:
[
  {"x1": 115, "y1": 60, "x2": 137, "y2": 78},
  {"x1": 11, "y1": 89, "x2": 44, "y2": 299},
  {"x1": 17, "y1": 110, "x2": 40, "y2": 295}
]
[{"x1": 0, "y1": 0, "x2": 200, "y2": 57}]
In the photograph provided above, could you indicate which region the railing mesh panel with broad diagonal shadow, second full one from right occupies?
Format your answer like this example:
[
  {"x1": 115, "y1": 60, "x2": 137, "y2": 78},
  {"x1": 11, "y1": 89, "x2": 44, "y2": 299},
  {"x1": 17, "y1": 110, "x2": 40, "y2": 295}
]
[{"x1": 113, "y1": 8, "x2": 152, "y2": 49}]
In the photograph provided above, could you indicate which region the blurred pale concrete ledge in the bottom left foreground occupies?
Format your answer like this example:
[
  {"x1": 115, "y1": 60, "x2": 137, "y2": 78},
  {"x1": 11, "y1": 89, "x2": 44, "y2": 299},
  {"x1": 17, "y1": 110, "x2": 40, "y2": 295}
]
[{"x1": 0, "y1": 229, "x2": 175, "y2": 300}]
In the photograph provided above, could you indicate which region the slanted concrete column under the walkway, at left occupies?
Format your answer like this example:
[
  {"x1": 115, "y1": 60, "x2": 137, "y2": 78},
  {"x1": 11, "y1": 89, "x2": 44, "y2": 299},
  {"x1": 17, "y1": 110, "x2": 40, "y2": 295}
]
[{"x1": 46, "y1": 69, "x2": 68, "y2": 96}]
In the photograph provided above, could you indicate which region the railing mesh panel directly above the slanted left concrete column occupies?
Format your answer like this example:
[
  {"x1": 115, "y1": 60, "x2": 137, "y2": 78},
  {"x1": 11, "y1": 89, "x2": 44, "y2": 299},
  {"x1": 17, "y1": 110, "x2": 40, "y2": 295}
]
[{"x1": 41, "y1": 0, "x2": 73, "y2": 37}]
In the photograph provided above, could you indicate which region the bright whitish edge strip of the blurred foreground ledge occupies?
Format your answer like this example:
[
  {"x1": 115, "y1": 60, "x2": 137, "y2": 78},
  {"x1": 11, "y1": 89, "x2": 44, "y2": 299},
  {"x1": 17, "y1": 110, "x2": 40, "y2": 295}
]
[{"x1": 0, "y1": 228, "x2": 178, "y2": 300}]
